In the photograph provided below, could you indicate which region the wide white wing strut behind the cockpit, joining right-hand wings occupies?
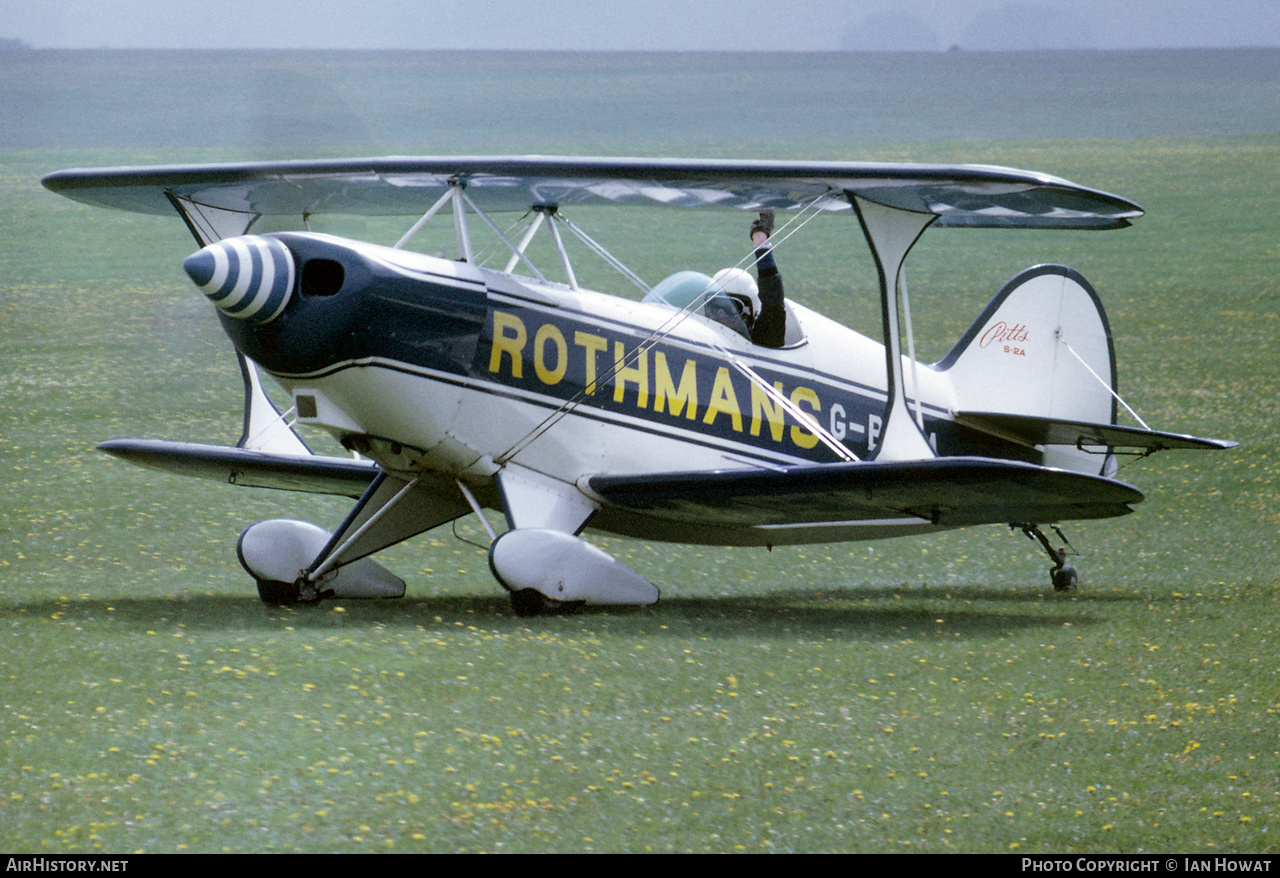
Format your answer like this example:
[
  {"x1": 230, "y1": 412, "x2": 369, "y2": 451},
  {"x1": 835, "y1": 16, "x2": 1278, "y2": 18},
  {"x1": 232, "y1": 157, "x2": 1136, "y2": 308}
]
[{"x1": 849, "y1": 192, "x2": 937, "y2": 461}]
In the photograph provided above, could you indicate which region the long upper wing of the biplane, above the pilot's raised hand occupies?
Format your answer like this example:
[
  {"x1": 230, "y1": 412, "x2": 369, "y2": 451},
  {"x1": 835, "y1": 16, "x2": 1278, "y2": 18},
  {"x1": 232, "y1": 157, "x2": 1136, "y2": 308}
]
[{"x1": 44, "y1": 156, "x2": 1142, "y2": 229}]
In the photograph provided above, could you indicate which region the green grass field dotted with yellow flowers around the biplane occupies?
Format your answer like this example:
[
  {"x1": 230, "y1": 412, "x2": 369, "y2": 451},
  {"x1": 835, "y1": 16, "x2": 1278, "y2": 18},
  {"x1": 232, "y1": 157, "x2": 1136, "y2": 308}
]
[{"x1": 0, "y1": 47, "x2": 1280, "y2": 852}]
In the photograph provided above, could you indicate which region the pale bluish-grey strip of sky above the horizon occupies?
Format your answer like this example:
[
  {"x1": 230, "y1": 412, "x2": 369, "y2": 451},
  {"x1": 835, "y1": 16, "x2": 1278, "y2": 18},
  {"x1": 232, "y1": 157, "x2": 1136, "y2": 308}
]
[{"x1": 0, "y1": 0, "x2": 1280, "y2": 51}]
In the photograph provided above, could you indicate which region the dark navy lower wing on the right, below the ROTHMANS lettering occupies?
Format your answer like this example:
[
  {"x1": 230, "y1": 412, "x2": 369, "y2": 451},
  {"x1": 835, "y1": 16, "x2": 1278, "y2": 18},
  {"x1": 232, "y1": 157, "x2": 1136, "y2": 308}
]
[{"x1": 589, "y1": 457, "x2": 1142, "y2": 527}]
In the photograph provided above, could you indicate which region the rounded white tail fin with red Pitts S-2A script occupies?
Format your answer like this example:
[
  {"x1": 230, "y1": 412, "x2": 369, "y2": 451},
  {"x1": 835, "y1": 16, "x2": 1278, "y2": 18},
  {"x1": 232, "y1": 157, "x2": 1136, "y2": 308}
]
[{"x1": 936, "y1": 265, "x2": 1116, "y2": 475}]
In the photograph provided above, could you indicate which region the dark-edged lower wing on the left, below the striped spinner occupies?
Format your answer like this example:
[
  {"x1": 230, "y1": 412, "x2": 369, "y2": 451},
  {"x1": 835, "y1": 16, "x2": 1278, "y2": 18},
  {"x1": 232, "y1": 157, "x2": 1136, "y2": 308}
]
[{"x1": 99, "y1": 439, "x2": 378, "y2": 498}]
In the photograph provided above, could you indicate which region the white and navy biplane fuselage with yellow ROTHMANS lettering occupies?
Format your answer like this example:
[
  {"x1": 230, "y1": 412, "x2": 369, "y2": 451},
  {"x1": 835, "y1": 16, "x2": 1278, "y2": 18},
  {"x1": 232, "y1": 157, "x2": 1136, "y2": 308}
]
[{"x1": 209, "y1": 234, "x2": 1027, "y2": 541}]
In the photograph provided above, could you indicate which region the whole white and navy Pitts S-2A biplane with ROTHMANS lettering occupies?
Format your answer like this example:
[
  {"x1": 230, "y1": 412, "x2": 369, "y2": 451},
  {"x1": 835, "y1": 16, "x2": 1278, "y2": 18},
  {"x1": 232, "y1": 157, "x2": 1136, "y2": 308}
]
[{"x1": 44, "y1": 156, "x2": 1235, "y2": 614}]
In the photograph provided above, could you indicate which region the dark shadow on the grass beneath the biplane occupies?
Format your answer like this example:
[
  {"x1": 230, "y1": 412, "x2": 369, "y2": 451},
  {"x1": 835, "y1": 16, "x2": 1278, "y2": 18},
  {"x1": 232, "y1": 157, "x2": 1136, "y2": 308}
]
[{"x1": 24, "y1": 586, "x2": 1158, "y2": 640}]
